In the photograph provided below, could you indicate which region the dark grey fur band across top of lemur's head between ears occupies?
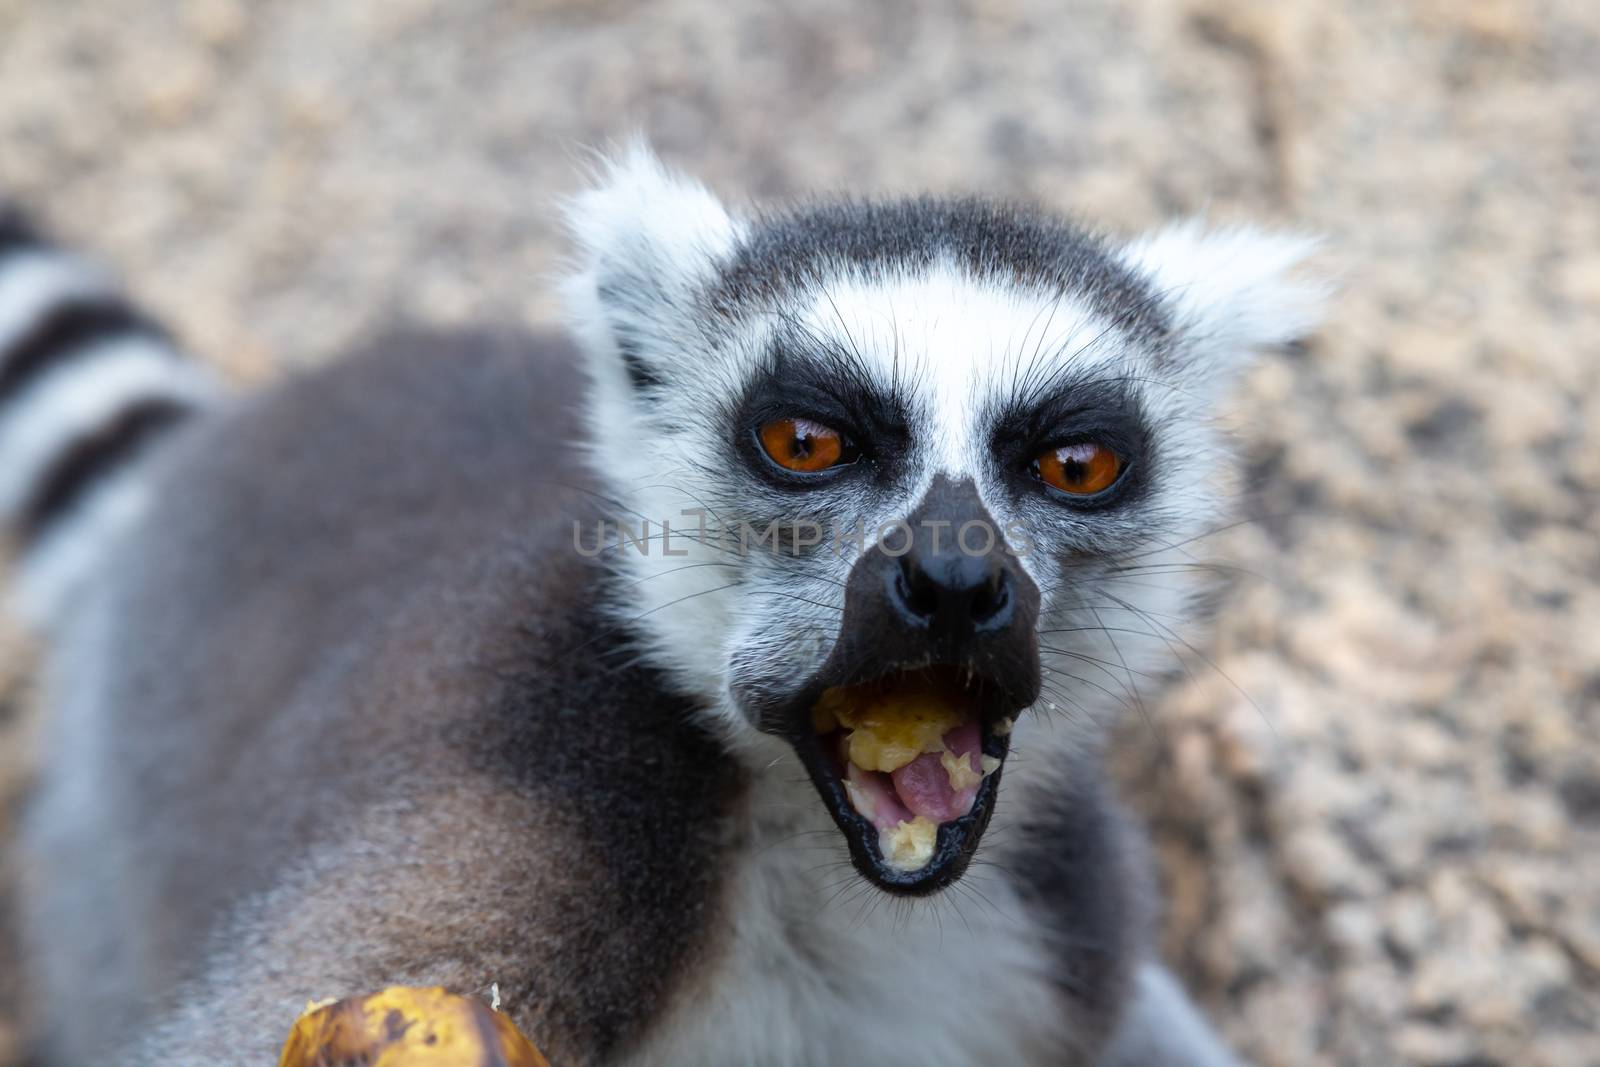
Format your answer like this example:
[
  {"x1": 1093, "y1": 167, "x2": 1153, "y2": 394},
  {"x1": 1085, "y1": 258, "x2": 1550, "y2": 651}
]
[{"x1": 712, "y1": 197, "x2": 1170, "y2": 339}]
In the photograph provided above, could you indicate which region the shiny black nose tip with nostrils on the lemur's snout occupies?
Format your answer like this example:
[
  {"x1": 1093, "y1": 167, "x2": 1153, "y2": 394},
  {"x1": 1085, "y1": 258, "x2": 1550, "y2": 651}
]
[{"x1": 888, "y1": 537, "x2": 1011, "y2": 637}]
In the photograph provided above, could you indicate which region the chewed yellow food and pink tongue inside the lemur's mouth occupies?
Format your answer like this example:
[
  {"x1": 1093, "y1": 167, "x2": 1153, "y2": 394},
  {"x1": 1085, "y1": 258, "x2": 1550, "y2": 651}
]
[{"x1": 811, "y1": 670, "x2": 1000, "y2": 872}]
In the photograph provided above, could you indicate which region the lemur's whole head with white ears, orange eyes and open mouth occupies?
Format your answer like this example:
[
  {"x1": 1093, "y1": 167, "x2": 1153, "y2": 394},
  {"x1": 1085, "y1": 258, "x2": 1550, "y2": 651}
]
[{"x1": 566, "y1": 147, "x2": 1322, "y2": 893}]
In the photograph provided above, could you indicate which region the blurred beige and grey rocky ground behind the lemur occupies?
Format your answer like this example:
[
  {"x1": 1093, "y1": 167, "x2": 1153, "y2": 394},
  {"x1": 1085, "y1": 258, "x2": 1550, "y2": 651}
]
[{"x1": 0, "y1": 0, "x2": 1600, "y2": 1067}]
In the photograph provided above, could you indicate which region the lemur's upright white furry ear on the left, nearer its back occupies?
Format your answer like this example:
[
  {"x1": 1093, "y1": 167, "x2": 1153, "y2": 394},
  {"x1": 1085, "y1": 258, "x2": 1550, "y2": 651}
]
[{"x1": 563, "y1": 141, "x2": 741, "y2": 389}]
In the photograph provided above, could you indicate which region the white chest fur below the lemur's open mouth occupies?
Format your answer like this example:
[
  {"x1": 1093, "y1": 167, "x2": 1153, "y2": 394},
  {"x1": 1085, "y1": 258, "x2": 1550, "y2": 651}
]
[{"x1": 629, "y1": 755, "x2": 1072, "y2": 1067}]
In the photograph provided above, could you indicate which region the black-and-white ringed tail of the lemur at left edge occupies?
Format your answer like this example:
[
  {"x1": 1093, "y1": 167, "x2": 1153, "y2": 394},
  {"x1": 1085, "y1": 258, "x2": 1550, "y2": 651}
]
[{"x1": 0, "y1": 205, "x2": 216, "y2": 625}]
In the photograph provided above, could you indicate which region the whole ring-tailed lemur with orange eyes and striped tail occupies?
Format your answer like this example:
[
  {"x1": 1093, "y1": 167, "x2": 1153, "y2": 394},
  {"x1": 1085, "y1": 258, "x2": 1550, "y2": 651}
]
[{"x1": 0, "y1": 147, "x2": 1323, "y2": 1067}]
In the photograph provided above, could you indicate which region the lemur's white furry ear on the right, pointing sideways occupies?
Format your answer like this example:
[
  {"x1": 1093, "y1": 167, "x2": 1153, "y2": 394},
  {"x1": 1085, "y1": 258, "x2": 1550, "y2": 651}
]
[{"x1": 1123, "y1": 219, "x2": 1333, "y2": 383}]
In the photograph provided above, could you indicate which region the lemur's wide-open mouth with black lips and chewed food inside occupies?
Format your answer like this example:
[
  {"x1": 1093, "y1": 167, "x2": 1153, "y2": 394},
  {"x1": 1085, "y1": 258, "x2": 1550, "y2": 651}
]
[{"x1": 794, "y1": 667, "x2": 1016, "y2": 894}]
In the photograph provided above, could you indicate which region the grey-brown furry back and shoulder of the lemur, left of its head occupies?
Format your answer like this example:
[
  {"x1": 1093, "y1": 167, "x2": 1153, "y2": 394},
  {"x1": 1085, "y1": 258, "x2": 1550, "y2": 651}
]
[{"x1": 26, "y1": 334, "x2": 739, "y2": 1064}]
